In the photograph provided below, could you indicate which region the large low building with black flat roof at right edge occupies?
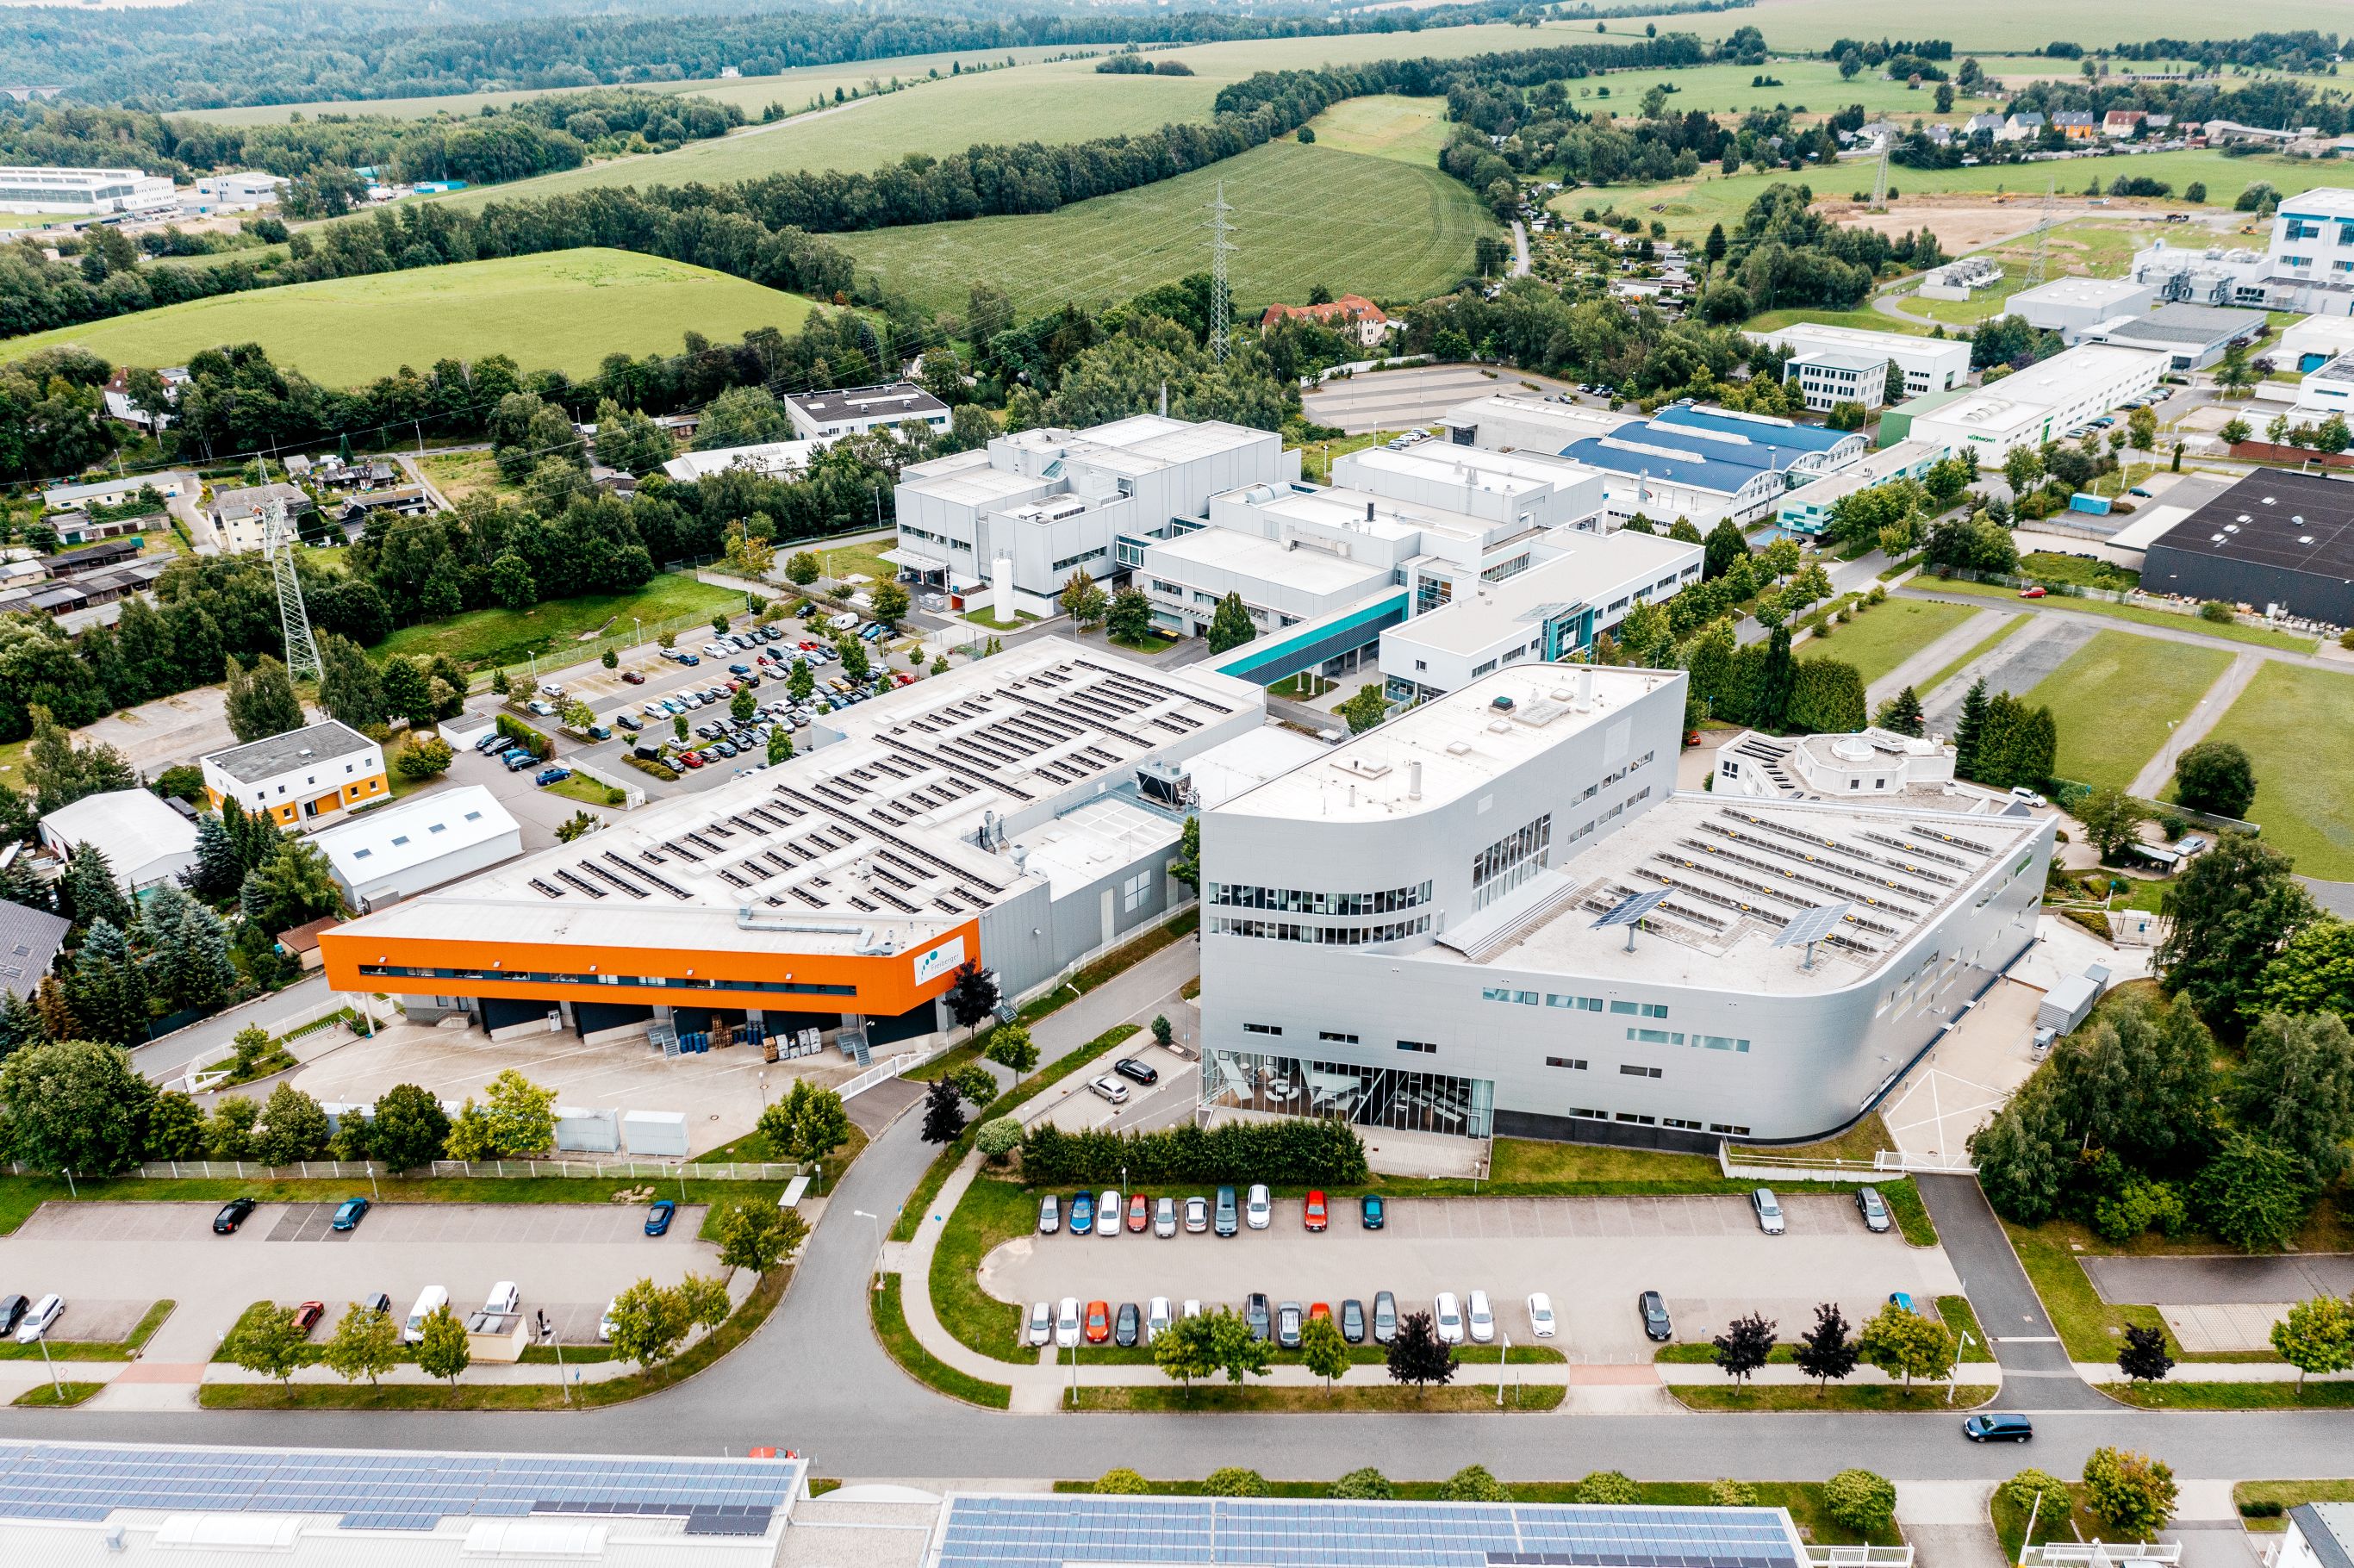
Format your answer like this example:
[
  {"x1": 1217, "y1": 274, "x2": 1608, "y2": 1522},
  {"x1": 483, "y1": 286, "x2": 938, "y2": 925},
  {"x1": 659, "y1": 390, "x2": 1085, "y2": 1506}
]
[{"x1": 2142, "y1": 469, "x2": 2354, "y2": 626}]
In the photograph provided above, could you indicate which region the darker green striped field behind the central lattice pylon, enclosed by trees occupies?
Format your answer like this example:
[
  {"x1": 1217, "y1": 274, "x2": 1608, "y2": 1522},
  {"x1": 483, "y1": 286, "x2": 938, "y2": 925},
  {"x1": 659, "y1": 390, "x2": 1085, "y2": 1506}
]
[{"x1": 836, "y1": 141, "x2": 1495, "y2": 313}]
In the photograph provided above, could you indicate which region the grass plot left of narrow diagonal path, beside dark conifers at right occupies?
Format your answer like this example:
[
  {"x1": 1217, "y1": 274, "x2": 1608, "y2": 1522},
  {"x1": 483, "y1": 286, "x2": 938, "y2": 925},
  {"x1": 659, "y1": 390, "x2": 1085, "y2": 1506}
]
[{"x1": 2025, "y1": 631, "x2": 2232, "y2": 788}]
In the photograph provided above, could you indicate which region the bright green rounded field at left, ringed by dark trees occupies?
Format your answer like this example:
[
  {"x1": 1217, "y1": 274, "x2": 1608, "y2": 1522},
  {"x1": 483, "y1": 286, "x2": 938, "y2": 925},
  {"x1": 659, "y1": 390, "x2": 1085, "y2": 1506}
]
[{"x1": 0, "y1": 250, "x2": 813, "y2": 386}]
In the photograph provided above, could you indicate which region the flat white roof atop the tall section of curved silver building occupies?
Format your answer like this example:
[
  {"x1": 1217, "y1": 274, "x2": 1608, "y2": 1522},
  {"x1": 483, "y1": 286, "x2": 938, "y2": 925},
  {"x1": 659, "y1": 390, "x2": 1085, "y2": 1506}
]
[{"x1": 1222, "y1": 664, "x2": 1683, "y2": 822}]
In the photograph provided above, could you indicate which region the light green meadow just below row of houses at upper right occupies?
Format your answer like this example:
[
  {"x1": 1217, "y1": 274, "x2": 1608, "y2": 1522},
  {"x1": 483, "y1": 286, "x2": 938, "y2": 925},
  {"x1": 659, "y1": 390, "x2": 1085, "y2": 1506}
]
[{"x1": 1600, "y1": 148, "x2": 2342, "y2": 242}]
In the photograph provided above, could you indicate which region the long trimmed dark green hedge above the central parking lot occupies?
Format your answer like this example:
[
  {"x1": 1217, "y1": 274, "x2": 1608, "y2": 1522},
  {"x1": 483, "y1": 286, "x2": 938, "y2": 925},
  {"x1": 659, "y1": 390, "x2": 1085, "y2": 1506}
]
[{"x1": 1022, "y1": 1121, "x2": 1366, "y2": 1186}]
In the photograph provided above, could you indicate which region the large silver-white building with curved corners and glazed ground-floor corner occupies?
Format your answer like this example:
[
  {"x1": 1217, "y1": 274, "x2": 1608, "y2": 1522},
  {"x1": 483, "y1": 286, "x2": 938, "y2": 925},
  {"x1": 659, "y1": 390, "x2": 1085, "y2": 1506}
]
[{"x1": 1200, "y1": 666, "x2": 2058, "y2": 1149}]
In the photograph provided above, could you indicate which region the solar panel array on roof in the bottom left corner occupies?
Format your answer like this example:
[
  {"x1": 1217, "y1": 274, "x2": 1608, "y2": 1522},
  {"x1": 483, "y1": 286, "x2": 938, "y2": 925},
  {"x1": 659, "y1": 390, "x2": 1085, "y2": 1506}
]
[{"x1": 0, "y1": 1443, "x2": 800, "y2": 1535}]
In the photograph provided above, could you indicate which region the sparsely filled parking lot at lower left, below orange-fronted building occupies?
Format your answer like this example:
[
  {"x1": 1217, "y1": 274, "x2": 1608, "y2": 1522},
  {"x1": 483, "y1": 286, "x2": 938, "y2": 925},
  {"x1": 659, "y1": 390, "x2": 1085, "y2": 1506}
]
[{"x1": 0, "y1": 1182, "x2": 718, "y2": 1363}]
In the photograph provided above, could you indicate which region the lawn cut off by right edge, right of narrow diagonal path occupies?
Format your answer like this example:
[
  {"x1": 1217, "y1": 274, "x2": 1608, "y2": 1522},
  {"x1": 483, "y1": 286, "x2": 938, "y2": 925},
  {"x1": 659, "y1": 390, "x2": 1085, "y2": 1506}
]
[{"x1": 2210, "y1": 662, "x2": 2354, "y2": 880}]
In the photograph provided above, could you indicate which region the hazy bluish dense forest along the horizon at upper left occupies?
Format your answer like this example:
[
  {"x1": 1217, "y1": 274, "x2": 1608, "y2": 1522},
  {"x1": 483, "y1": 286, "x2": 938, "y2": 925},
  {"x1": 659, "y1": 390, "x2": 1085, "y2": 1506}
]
[{"x1": 0, "y1": 0, "x2": 1752, "y2": 109}]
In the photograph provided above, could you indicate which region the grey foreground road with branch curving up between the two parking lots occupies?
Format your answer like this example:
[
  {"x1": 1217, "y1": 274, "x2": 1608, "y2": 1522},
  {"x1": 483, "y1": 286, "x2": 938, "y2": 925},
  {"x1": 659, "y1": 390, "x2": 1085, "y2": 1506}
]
[{"x1": 14, "y1": 1087, "x2": 2354, "y2": 1481}]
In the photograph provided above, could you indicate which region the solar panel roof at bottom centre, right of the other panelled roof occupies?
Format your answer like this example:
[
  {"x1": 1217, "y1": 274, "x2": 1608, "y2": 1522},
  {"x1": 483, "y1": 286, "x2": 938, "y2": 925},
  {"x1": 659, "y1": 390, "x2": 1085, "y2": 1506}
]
[{"x1": 939, "y1": 1495, "x2": 1801, "y2": 1568}]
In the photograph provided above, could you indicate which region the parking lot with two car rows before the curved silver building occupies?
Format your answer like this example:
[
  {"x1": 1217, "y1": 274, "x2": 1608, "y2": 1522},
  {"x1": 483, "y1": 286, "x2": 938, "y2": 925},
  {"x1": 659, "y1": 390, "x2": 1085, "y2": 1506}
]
[{"x1": 980, "y1": 1192, "x2": 1961, "y2": 1363}]
